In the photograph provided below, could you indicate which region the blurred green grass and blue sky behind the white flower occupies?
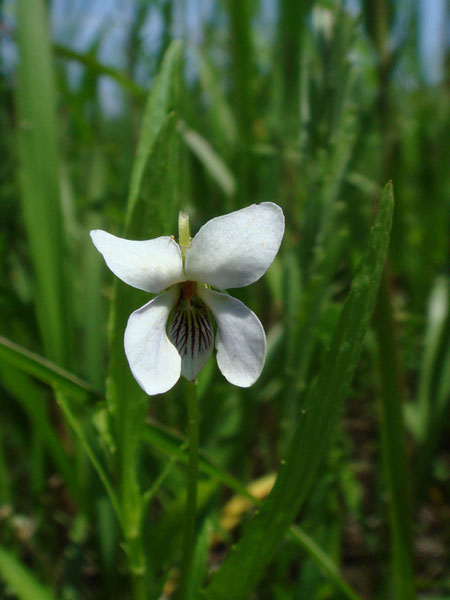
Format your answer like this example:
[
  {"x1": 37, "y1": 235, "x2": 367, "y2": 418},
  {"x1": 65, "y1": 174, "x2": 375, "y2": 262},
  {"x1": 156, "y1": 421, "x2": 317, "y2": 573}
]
[{"x1": 0, "y1": 0, "x2": 450, "y2": 600}]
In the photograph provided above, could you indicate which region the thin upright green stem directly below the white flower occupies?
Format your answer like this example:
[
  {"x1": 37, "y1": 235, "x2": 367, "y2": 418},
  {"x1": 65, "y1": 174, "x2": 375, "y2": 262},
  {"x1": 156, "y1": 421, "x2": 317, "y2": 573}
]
[{"x1": 180, "y1": 382, "x2": 199, "y2": 598}]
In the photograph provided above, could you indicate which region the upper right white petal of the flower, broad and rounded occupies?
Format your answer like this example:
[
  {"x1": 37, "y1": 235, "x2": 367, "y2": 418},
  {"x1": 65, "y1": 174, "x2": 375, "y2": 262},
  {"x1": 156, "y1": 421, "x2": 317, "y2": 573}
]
[{"x1": 185, "y1": 202, "x2": 284, "y2": 289}]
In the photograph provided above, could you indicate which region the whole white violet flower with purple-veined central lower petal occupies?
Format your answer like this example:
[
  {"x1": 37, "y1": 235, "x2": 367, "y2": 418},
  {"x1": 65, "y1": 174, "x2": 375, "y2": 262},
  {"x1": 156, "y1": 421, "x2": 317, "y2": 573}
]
[{"x1": 91, "y1": 202, "x2": 284, "y2": 394}]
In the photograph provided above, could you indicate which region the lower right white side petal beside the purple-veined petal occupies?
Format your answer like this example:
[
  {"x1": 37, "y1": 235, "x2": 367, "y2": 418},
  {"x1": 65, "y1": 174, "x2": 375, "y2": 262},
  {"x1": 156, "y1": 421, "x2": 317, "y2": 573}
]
[{"x1": 198, "y1": 288, "x2": 266, "y2": 387}]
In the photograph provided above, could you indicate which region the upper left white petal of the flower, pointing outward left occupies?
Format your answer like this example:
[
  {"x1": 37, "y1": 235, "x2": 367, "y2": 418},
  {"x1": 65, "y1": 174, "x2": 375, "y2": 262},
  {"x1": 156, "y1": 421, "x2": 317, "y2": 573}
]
[{"x1": 91, "y1": 229, "x2": 185, "y2": 294}]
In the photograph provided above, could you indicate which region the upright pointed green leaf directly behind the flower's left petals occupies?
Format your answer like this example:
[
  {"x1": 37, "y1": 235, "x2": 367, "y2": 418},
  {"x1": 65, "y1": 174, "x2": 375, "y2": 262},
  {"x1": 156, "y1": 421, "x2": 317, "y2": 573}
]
[{"x1": 103, "y1": 42, "x2": 181, "y2": 573}]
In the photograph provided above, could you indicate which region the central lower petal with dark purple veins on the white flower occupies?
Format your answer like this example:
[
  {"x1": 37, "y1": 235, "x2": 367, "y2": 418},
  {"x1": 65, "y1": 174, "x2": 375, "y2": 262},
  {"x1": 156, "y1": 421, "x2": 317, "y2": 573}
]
[{"x1": 169, "y1": 293, "x2": 214, "y2": 381}]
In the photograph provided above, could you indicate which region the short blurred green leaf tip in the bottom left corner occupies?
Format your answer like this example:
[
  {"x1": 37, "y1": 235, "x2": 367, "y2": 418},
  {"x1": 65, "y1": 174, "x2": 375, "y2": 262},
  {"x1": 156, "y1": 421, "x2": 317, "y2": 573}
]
[{"x1": 0, "y1": 546, "x2": 56, "y2": 600}]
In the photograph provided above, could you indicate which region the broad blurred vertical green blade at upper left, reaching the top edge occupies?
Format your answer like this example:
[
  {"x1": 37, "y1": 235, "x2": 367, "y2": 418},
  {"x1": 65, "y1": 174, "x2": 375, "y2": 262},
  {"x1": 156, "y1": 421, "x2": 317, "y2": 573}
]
[{"x1": 15, "y1": 0, "x2": 73, "y2": 366}]
